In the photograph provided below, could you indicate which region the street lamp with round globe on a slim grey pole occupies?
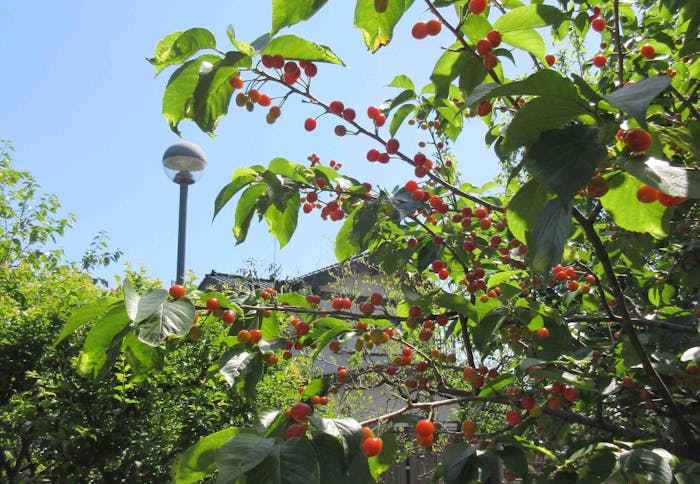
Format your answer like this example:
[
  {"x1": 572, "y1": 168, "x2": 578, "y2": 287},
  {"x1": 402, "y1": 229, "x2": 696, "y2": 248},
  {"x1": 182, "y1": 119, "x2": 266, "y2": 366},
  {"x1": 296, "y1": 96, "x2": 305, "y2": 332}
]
[{"x1": 163, "y1": 141, "x2": 207, "y2": 284}]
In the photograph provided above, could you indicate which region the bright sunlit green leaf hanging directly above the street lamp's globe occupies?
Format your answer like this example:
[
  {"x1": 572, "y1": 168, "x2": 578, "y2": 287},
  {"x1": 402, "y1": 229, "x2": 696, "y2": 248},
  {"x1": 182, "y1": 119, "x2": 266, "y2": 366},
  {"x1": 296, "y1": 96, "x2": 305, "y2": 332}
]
[{"x1": 163, "y1": 54, "x2": 221, "y2": 135}]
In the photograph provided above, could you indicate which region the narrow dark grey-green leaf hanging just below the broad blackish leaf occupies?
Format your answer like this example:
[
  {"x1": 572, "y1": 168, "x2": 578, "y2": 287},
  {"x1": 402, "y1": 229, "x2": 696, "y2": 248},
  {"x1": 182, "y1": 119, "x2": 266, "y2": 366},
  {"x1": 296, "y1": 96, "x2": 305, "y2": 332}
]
[{"x1": 526, "y1": 199, "x2": 571, "y2": 273}]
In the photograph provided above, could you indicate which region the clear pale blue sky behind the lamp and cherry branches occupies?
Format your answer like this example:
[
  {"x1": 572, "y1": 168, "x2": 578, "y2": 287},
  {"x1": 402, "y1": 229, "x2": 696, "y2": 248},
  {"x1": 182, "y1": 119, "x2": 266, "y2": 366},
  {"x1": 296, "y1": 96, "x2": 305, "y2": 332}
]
[{"x1": 0, "y1": 0, "x2": 496, "y2": 284}]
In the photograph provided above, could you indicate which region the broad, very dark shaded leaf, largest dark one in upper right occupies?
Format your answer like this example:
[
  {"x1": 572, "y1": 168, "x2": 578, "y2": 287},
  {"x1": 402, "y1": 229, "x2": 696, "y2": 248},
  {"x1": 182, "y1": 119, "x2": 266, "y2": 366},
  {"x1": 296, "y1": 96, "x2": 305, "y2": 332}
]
[{"x1": 525, "y1": 125, "x2": 607, "y2": 202}]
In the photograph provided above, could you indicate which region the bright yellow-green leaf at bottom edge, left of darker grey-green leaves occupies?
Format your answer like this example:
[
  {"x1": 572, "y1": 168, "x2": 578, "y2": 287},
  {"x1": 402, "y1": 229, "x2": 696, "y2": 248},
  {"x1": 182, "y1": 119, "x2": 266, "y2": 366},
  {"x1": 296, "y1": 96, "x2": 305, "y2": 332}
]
[{"x1": 170, "y1": 427, "x2": 242, "y2": 484}]
